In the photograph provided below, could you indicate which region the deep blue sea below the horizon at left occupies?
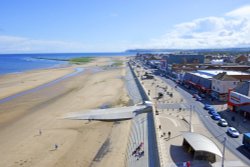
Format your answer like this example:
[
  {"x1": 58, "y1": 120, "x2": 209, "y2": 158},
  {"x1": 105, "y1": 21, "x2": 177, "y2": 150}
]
[{"x1": 0, "y1": 52, "x2": 133, "y2": 75}]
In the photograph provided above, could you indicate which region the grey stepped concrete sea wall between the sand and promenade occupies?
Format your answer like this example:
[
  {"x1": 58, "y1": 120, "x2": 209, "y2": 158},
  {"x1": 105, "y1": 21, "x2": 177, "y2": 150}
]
[{"x1": 126, "y1": 64, "x2": 160, "y2": 167}]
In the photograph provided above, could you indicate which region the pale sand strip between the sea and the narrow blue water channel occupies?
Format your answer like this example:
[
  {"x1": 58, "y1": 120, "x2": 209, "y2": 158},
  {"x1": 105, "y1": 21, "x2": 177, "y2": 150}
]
[{"x1": 0, "y1": 56, "x2": 123, "y2": 101}]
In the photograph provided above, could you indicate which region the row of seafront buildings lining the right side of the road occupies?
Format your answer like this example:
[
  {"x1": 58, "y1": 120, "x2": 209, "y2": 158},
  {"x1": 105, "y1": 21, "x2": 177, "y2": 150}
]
[{"x1": 136, "y1": 53, "x2": 250, "y2": 117}]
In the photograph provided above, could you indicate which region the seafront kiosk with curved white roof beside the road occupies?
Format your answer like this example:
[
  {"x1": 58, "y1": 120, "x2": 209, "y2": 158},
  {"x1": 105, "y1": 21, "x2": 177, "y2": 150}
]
[{"x1": 182, "y1": 132, "x2": 222, "y2": 163}]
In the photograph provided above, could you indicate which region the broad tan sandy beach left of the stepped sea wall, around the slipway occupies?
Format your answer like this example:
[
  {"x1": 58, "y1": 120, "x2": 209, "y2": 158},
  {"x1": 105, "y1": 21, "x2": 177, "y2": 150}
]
[{"x1": 0, "y1": 58, "x2": 130, "y2": 167}]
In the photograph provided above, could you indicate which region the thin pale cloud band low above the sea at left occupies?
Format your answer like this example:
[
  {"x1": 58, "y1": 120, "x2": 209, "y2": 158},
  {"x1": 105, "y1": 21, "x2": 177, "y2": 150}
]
[{"x1": 0, "y1": 35, "x2": 134, "y2": 53}]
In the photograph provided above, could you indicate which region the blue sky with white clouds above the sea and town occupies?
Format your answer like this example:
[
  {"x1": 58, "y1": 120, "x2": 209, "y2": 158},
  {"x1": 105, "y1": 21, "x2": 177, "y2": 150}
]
[{"x1": 0, "y1": 0, "x2": 250, "y2": 53}]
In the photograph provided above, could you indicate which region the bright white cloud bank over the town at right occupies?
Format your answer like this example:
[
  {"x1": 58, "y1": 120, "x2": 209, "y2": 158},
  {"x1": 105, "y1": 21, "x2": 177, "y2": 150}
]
[{"x1": 138, "y1": 6, "x2": 250, "y2": 49}]
